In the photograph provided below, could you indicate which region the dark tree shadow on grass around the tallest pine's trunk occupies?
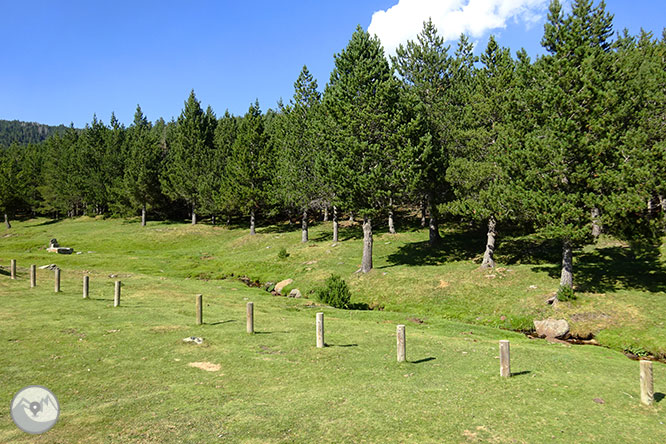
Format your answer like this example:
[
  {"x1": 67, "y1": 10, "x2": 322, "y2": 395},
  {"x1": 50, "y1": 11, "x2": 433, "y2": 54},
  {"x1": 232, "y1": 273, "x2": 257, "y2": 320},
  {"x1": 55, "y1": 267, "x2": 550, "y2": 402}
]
[{"x1": 532, "y1": 247, "x2": 666, "y2": 293}]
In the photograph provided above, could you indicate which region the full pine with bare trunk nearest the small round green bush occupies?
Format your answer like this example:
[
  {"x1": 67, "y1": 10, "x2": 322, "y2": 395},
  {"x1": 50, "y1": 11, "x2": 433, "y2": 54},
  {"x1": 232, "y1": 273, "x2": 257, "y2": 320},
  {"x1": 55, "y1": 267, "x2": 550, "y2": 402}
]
[{"x1": 323, "y1": 26, "x2": 400, "y2": 273}]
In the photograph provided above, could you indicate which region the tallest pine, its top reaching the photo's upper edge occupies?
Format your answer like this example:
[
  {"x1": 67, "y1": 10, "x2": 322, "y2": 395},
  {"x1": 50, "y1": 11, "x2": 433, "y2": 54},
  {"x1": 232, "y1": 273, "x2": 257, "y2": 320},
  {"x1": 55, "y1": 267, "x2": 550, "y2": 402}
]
[{"x1": 513, "y1": 0, "x2": 618, "y2": 291}]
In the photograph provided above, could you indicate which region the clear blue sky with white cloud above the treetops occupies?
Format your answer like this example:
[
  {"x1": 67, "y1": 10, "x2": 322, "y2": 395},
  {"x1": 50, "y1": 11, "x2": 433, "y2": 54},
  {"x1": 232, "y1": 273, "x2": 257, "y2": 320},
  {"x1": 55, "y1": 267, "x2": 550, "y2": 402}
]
[{"x1": 0, "y1": 0, "x2": 666, "y2": 127}]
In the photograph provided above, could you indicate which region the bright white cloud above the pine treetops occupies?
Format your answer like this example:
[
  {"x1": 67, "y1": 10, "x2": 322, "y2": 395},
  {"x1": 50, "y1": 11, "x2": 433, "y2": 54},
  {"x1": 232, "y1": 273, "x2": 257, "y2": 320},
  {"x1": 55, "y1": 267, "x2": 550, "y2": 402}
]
[{"x1": 368, "y1": 0, "x2": 548, "y2": 54}]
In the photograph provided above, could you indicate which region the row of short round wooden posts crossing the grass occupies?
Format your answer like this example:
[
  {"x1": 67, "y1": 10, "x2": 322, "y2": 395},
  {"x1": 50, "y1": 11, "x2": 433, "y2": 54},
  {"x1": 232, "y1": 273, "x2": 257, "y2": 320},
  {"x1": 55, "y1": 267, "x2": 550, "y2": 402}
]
[{"x1": 10, "y1": 259, "x2": 654, "y2": 405}]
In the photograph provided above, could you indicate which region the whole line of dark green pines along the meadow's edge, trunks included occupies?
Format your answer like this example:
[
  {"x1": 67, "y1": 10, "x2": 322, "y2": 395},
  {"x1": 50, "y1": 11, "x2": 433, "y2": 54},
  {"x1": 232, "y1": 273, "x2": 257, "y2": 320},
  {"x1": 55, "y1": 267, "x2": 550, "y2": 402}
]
[{"x1": 0, "y1": 0, "x2": 666, "y2": 293}]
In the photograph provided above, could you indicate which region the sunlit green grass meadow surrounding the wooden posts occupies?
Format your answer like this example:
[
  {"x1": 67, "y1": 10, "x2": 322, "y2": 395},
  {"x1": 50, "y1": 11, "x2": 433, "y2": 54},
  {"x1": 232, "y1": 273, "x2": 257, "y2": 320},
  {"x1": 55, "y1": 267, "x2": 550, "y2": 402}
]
[{"x1": 0, "y1": 218, "x2": 666, "y2": 443}]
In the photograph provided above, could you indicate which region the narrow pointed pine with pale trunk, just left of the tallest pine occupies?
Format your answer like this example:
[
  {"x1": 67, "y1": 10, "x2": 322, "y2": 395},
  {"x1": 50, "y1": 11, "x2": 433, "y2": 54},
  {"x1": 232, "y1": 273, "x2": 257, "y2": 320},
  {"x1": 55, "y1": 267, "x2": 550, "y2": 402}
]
[{"x1": 447, "y1": 36, "x2": 522, "y2": 268}]
